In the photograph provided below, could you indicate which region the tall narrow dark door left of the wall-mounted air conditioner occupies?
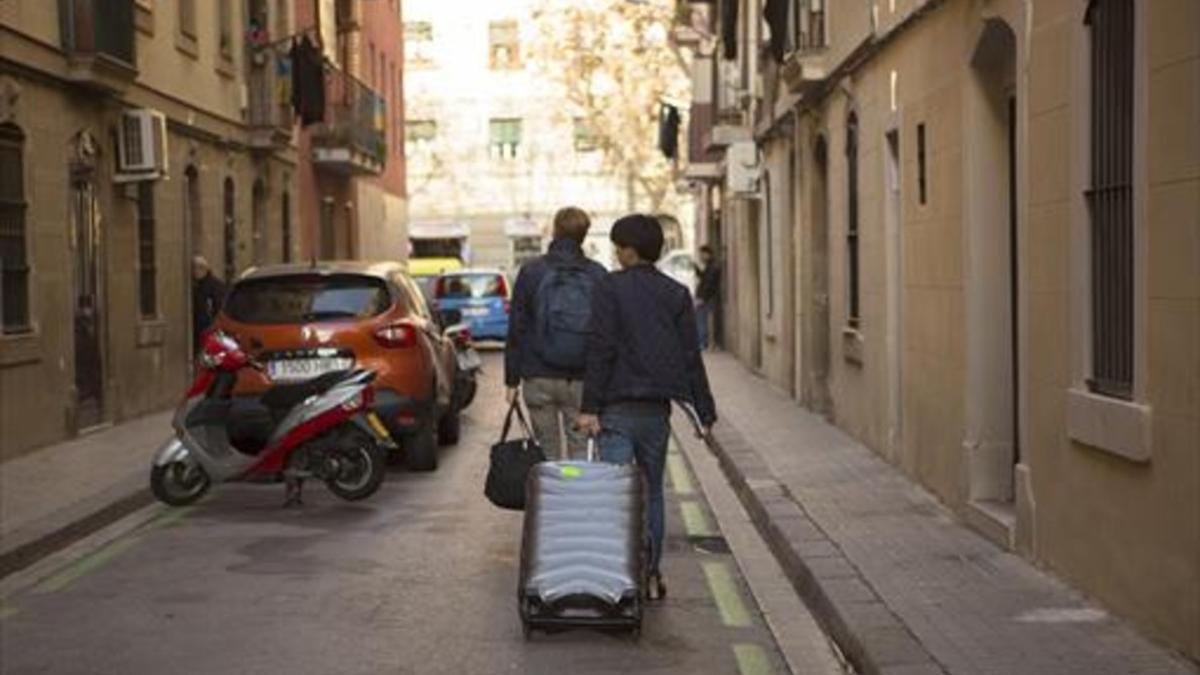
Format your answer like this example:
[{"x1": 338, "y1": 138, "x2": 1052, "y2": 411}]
[{"x1": 71, "y1": 172, "x2": 104, "y2": 431}]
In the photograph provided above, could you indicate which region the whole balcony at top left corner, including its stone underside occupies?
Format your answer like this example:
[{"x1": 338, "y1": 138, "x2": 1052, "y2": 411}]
[{"x1": 59, "y1": 0, "x2": 138, "y2": 92}]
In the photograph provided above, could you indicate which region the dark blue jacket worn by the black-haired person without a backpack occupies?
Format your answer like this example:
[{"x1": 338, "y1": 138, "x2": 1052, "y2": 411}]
[{"x1": 581, "y1": 264, "x2": 716, "y2": 426}]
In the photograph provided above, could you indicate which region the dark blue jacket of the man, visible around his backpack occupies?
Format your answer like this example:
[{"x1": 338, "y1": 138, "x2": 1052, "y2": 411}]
[{"x1": 504, "y1": 239, "x2": 607, "y2": 387}]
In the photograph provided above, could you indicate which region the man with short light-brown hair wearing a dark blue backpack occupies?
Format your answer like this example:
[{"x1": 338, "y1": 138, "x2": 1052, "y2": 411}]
[{"x1": 504, "y1": 207, "x2": 607, "y2": 459}]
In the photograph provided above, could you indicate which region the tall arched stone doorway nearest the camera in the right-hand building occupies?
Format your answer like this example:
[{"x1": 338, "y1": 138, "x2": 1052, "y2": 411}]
[{"x1": 964, "y1": 19, "x2": 1020, "y2": 509}]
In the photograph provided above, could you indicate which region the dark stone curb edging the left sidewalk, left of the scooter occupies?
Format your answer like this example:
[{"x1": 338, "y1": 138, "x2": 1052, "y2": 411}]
[{"x1": 0, "y1": 486, "x2": 155, "y2": 579}]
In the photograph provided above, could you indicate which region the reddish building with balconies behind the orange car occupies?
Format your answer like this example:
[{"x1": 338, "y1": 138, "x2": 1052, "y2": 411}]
[{"x1": 294, "y1": 0, "x2": 408, "y2": 259}]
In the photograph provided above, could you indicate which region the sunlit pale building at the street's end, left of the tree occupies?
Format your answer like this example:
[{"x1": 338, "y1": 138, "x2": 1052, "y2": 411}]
[{"x1": 404, "y1": 0, "x2": 635, "y2": 269}]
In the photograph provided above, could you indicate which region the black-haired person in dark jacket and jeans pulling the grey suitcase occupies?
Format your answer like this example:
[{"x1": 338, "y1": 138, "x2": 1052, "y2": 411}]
[{"x1": 578, "y1": 214, "x2": 716, "y2": 598}]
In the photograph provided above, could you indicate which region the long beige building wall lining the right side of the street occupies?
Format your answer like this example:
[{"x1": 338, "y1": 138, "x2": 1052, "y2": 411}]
[{"x1": 688, "y1": 0, "x2": 1200, "y2": 658}]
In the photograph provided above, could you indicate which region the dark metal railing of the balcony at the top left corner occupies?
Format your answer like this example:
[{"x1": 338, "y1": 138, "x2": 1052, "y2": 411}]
[{"x1": 59, "y1": 0, "x2": 136, "y2": 67}]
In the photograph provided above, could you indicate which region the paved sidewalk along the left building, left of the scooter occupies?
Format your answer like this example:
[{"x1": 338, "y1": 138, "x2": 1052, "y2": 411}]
[{"x1": 0, "y1": 412, "x2": 172, "y2": 578}]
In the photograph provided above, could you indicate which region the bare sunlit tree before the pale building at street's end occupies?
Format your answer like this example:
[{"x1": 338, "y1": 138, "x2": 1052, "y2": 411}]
[{"x1": 530, "y1": 0, "x2": 691, "y2": 213}]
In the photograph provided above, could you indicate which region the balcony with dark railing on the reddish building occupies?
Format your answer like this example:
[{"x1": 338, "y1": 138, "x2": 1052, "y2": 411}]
[{"x1": 312, "y1": 70, "x2": 388, "y2": 175}]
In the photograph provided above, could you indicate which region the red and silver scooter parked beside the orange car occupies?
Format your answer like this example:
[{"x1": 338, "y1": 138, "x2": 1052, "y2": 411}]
[{"x1": 150, "y1": 331, "x2": 396, "y2": 506}]
